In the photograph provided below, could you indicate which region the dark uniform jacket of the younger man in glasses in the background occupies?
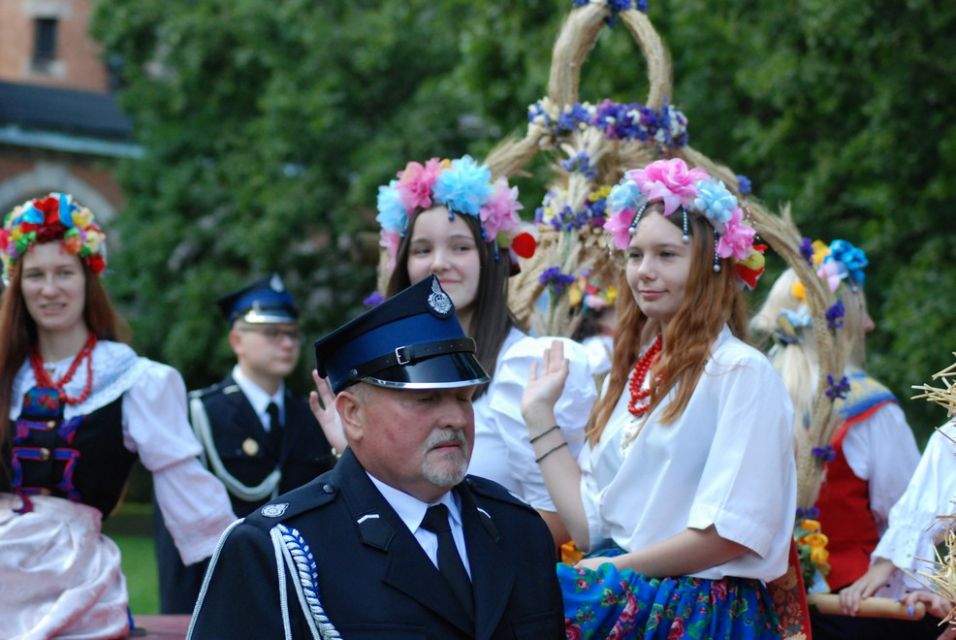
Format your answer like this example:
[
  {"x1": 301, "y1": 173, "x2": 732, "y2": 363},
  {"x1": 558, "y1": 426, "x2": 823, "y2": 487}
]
[{"x1": 154, "y1": 376, "x2": 335, "y2": 614}]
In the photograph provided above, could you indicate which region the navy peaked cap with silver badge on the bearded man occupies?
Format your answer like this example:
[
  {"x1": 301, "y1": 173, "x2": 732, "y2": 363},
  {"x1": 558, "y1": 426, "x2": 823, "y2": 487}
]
[{"x1": 315, "y1": 276, "x2": 489, "y2": 393}]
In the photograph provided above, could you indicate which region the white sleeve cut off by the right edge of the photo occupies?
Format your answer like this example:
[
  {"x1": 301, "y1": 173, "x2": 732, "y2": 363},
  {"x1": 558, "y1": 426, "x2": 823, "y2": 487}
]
[{"x1": 872, "y1": 422, "x2": 956, "y2": 571}]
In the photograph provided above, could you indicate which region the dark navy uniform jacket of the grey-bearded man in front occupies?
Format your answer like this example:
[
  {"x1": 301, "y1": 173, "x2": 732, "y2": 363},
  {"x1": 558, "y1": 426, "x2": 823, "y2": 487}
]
[{"x1": 190, "y1": 450, "x2": 564, "y2": 640}]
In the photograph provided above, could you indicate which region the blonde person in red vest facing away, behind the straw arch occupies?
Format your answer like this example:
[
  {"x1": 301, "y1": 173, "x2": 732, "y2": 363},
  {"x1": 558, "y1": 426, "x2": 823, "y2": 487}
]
[{"x1": 750, "y1": 246, "x2": 919, "y2": 638}]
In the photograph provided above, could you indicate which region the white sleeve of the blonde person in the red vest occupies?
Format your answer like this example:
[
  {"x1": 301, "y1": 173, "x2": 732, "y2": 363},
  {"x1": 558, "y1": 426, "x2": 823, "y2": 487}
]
[{"x1": 843, "y1": 402, "x2": 919, "y2": 534}]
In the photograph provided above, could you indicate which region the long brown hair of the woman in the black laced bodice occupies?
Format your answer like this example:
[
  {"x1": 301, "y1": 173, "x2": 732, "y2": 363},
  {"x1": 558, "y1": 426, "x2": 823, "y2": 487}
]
[{"x1": 0, "y1": 250, "x2": 129, "y2": 460}]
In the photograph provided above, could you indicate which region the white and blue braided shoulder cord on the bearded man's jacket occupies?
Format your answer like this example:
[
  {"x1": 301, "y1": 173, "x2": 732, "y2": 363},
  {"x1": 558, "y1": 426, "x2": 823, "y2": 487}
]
[{"x1": 270, "y1": 524, "x2": 342, "y2": 640}]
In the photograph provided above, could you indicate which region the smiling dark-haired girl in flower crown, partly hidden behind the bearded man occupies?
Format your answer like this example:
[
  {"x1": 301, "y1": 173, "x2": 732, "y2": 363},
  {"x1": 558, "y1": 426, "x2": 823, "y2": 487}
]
[{"x1": 312, "y1": 156, "x2": 597, "y2": 543}]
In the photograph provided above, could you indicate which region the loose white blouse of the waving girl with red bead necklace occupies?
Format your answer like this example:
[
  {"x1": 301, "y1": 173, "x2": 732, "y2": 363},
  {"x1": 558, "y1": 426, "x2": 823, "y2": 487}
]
[{"x1": 578, "y1": 327, "x2": 796, "y2": 581}]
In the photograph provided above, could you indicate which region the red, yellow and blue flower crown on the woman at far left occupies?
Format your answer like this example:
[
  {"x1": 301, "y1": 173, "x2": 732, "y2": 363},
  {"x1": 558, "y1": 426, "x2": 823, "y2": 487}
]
[{"x1": 0, "y1": 193, "x2": 106, "y2": 278}]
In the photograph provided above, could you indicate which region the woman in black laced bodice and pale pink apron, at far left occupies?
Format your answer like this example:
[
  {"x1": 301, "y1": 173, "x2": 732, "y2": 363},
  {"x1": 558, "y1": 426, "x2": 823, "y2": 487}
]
[{"x1": 0, "y1": 193, "x2": 234, "y2": 638}]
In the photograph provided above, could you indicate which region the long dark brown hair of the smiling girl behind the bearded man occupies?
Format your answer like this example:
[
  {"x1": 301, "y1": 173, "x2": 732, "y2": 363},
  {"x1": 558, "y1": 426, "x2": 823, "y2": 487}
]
[{"x1": 385, "y1": 208, "x2": 518, "y2": 398}]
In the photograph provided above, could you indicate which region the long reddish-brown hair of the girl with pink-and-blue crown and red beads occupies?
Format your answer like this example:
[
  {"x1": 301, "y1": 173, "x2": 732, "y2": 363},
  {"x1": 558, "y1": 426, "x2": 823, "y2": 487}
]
[{"x1": 587, "y1": 205, "x2": 747, "y2": 445}]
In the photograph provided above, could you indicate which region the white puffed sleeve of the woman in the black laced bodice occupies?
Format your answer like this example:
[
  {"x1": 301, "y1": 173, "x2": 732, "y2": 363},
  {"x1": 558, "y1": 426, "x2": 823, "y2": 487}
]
[{"x1": 123, "y1": 362, "x2": 235, "y2": 565}]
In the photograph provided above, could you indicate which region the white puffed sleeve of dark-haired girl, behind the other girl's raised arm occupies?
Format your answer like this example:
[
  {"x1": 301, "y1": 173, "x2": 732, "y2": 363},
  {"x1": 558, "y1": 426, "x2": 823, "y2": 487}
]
[{"x1": 488, "y1": 336, "x2": 597, "y2": 511}]
